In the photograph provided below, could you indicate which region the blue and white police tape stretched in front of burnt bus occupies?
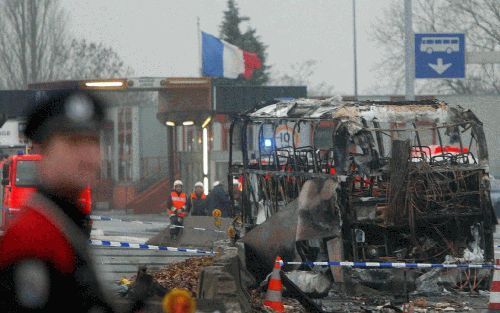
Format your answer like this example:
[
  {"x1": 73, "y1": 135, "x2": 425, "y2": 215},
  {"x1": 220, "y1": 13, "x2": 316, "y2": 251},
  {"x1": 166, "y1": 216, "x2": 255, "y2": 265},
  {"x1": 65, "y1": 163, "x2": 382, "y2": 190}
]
[{"x1": 276, "y1": 261, "x2": 494, "y2": 269}]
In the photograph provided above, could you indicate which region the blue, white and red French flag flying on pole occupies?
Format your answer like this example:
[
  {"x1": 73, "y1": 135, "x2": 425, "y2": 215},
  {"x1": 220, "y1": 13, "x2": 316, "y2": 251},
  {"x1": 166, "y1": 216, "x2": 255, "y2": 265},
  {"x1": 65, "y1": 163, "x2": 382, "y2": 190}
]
[{"x1": 201, "y1": 32, "x2": 262, "y2": 79}]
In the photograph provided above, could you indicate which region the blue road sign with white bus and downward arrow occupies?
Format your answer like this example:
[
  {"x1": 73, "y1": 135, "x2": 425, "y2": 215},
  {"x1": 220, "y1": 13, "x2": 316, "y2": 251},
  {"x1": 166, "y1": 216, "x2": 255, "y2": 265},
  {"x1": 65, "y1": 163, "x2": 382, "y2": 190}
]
[{"x1": 415, "y1": 33, "x2": 465, "y2": 78}]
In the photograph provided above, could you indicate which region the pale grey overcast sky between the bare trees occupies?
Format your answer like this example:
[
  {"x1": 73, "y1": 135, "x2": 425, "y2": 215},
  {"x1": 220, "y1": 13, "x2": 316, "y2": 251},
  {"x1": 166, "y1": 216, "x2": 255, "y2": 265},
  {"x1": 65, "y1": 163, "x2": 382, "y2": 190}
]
[{"x1": 63, "y1": 0, "x2": 391, "y2": 94}]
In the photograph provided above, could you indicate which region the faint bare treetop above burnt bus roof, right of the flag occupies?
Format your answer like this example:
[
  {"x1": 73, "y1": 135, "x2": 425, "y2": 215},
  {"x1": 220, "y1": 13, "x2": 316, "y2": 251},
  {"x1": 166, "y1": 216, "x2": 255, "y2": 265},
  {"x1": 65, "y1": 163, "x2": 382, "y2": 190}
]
[{"x1": 271, "y1": 60, "x2": 335, "y2": 97}]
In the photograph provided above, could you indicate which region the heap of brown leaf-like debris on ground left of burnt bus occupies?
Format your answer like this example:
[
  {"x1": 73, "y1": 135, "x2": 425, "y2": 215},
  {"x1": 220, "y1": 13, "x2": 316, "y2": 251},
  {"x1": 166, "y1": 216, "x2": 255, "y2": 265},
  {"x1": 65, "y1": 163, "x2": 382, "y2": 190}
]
[{"x1": 146, "y1": 256, "x2": 214, "y2": 296}]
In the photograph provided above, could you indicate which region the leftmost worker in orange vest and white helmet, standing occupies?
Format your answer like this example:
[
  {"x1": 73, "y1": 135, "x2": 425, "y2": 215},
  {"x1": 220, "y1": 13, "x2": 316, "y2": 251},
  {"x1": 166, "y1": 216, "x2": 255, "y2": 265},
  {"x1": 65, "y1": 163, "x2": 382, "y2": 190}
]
[{"x1": 167, "y1": 180, "x2": 187, "y2": 240}]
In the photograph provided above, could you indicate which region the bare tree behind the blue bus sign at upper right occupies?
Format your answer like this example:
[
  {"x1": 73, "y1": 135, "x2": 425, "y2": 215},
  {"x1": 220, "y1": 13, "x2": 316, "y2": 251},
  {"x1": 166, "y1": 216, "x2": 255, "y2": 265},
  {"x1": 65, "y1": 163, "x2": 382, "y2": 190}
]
[{"x1": 372, "y1": 0, "x2": 500, "y2": 94}]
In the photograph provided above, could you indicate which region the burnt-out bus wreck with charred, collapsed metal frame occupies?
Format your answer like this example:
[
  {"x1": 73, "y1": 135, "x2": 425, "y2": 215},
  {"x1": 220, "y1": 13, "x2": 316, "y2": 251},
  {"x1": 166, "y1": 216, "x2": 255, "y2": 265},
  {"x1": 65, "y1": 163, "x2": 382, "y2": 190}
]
[{"x1": 230, "y1": 99, "x2": 497, "y2": 278}]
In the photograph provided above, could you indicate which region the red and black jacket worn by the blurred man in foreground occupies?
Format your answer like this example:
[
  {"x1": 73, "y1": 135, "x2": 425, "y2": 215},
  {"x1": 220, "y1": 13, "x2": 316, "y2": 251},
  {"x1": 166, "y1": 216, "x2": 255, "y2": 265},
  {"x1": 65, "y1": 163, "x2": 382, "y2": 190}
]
[{"x1": 0, "y1": 193, "x2": 113, "y2": 313}]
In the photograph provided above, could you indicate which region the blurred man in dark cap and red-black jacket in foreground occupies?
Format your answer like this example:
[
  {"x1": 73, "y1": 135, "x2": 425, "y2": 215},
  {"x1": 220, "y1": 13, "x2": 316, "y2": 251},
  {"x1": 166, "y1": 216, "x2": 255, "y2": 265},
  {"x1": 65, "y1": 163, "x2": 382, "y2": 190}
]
[{"x1": 0, "y1": 92, "x2": 117, "y2": 313}]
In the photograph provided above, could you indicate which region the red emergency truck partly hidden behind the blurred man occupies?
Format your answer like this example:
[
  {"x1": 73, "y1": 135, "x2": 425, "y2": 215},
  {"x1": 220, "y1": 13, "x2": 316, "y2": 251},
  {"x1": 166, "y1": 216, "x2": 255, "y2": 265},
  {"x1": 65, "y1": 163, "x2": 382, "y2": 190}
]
[{"x1": 0, "y1": 154, "x2": 92, "y2": 229}]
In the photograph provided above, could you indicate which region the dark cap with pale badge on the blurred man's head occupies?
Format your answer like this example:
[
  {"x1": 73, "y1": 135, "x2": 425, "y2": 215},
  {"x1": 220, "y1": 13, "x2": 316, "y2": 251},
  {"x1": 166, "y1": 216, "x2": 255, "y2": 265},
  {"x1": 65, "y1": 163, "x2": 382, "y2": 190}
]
[{"x1": 24, "y1": 91, "x2": 105, "y2": 143}]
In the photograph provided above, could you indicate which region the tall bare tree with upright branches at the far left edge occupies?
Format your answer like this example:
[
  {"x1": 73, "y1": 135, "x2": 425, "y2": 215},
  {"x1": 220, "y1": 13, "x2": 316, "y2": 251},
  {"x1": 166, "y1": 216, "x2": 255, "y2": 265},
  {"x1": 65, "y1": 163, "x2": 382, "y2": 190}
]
[{"x1": 0, "y1": 0, "x2": 67, "y2": 89}]
